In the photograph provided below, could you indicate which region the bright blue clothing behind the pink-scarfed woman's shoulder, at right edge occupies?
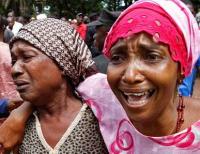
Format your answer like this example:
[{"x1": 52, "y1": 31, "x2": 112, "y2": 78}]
[{"x1": 178, "y1": 58, "x2": 200, "y2": 96}]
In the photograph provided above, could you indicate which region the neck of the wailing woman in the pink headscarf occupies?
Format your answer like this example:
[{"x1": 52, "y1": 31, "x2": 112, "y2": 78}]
[{"x1": 132, "y1": 95, "x2": 178, "y2": 137}]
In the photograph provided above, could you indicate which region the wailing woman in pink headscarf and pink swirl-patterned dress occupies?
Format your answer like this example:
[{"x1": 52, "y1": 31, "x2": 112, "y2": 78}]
[{"x1": 79, "y1": 0, "x2": 200, "y2": 154}]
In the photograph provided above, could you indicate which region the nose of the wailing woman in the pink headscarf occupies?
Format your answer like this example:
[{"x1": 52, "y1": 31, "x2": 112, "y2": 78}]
[{"x1": 122, "y1": 62, "x2": 145, "y2": 84}]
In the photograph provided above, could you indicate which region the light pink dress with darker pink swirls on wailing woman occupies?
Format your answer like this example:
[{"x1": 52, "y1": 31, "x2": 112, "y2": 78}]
[{"x1": 77, "y1": 73, "x2": 200, "y2": 154}]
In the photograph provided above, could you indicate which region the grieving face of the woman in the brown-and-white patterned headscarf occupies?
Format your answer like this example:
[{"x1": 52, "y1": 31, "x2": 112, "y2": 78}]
[{"x1": 11, "y1": 41, "x2": 63, "y2": 105}]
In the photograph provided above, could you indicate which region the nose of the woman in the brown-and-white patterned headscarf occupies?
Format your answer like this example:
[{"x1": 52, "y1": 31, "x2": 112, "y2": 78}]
[{"x1": 11, "y1": 60, "x2": 24, "y2": 79}]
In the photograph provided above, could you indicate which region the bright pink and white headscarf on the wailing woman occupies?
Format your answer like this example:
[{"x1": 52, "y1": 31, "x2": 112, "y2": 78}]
[{"x1": 104, "y1": 0, "x2": 200, "y2": 76}]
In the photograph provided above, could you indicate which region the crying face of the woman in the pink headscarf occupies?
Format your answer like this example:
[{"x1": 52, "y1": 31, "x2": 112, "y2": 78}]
[{"x1": 107, "y1": 34, "x2": 178, "y2": 122}]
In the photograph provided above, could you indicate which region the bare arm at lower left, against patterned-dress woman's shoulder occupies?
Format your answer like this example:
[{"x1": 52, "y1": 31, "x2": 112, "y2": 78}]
[{"x1": 0, "y1": 102, "x2": 33, "y2": 153}]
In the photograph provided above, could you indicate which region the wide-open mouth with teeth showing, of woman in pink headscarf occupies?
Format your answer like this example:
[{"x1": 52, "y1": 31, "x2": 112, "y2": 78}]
[{"x1": 123, "y1": 89, "x2": 156, "y2": 107}]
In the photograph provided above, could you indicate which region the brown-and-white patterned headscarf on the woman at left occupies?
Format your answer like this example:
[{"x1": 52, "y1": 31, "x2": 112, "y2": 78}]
[{"x1": 10, "y1": 18, "x2": 94, "y2": 85}]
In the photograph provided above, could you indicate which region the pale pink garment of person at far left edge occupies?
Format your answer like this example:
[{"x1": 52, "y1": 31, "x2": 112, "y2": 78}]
[{"x1": 0, "y1": 42, "x2": 20, "y2": 99}]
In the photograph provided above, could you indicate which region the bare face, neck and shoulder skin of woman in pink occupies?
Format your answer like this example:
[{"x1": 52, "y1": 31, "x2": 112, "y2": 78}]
[{"x1": 107, "y1": 34, "x2": 200, "y2": 136}]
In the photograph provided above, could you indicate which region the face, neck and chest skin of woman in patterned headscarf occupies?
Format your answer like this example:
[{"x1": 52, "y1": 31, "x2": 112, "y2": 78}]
[{"x1": 11, "y1": 41, "x2": 82, "y2": 147}]
